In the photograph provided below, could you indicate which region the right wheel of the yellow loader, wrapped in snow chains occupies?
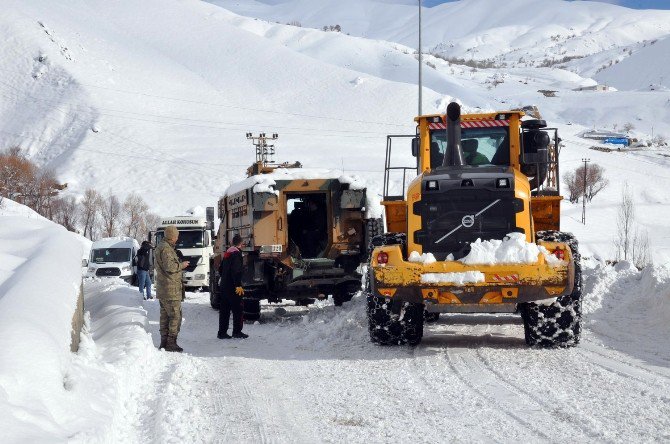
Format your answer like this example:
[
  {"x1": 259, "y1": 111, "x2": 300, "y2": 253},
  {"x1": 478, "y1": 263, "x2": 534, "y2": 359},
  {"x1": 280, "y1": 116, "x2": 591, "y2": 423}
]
[{"x1": 520, "y1": 231, "x2": 582, "y2": 347}]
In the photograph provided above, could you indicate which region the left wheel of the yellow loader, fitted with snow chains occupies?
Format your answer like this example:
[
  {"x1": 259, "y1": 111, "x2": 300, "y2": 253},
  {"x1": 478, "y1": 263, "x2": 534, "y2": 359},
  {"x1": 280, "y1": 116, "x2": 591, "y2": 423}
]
[{"x1": 367, "y1": 294, "x2": 423, "y2": 345}]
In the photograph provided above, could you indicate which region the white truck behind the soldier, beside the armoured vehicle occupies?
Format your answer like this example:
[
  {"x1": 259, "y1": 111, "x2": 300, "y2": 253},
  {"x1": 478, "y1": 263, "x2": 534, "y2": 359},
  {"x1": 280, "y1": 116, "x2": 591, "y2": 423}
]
[{"x1": 154, "y1": 211, "x2": 214, "y2": 288}]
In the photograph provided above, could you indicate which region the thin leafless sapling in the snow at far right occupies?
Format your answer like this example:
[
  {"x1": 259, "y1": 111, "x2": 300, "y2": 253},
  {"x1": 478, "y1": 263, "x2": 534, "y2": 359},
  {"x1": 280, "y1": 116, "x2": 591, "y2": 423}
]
[{"x1": 614, "y1": 183, "x2": 651, "y2": 268}]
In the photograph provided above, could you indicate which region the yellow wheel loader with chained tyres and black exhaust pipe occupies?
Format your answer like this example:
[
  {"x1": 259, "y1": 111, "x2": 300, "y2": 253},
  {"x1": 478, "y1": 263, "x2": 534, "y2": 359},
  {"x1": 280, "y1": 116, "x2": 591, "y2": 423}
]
[{"x1": 366, "y1": 103, "x2": 581, "y2": 347}]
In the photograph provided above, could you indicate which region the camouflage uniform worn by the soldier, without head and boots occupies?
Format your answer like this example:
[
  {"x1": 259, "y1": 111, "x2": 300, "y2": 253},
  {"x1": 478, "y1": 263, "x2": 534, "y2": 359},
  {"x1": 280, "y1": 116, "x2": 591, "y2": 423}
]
[{"x1": 155, "y1": 240, "x2": 183, "y2": 337}]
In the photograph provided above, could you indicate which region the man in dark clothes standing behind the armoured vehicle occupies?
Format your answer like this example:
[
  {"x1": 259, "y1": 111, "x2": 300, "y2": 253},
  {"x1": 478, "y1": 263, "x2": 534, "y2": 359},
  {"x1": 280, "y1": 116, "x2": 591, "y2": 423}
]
[{"x1": 216, "y1": 234, "x2": 249, "y2": 339}]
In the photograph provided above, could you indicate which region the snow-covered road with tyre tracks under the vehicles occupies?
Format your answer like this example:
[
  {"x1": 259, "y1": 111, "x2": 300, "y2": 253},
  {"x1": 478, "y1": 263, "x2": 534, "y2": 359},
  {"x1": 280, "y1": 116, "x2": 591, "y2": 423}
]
[{"x1": 133, "y1": 268, "x2": 670, "y2": 443}]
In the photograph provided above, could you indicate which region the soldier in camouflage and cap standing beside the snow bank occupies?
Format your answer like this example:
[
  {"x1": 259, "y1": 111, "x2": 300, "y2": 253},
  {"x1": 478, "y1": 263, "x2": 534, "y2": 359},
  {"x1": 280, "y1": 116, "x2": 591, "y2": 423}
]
[{"x1": 155, "y1": 225, "x2": 188, "y2": 352}]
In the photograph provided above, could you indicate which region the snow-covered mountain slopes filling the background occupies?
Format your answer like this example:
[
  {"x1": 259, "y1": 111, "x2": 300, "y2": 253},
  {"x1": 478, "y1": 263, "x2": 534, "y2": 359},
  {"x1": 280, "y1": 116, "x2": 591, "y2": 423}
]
[{"x1": 0, "y1": 0, "x2": 670, "y2": 258}]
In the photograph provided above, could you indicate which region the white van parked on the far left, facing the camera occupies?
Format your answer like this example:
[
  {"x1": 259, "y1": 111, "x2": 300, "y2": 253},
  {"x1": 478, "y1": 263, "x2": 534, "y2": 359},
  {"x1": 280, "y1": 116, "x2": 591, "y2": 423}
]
[{"x1": 86, "y1": 236, "x2": 140, "y2": 285}]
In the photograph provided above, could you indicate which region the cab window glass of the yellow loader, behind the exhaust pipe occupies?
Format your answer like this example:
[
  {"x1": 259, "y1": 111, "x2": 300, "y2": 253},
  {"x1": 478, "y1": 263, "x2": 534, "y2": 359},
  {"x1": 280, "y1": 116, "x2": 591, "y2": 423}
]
[{"x1": 430, "y1": 127, "x2": 509, "y2": 168}]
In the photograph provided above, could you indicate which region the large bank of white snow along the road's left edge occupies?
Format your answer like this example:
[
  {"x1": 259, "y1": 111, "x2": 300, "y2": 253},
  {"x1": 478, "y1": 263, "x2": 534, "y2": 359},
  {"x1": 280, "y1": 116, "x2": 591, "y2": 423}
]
[{"x1": 0, "y1": 199, "x2": 160, "y2": 442}]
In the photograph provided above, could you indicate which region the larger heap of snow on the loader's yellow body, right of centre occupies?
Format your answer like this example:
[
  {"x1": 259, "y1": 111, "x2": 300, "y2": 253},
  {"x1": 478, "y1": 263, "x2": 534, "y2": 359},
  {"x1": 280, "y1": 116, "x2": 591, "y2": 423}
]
[{"x1": 459, "y1": 233, "x2": 563, "y2": 266}]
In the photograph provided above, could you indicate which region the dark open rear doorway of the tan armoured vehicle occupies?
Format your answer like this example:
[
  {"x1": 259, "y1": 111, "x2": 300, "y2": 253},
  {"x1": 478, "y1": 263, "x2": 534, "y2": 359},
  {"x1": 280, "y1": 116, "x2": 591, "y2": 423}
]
[{"x1": 286, "y1": 193, "x2": 328, "y2": 259}]
